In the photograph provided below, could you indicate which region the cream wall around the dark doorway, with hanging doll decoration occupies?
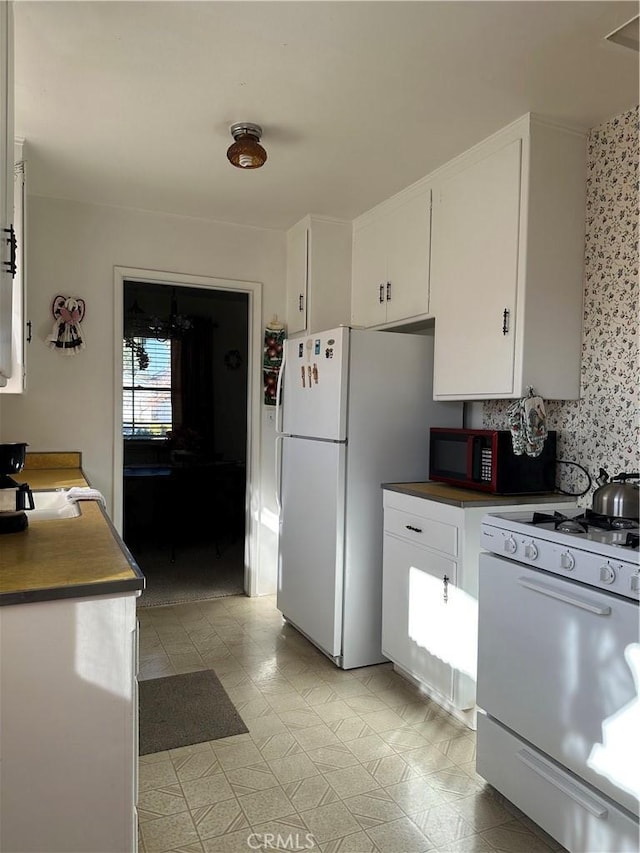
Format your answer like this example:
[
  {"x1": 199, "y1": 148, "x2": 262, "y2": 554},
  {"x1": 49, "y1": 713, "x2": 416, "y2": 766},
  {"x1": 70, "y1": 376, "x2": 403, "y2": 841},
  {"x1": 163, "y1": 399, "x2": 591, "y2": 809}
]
[{"x1": 0, "y1": 197, "x2": 285, "y2": 592}]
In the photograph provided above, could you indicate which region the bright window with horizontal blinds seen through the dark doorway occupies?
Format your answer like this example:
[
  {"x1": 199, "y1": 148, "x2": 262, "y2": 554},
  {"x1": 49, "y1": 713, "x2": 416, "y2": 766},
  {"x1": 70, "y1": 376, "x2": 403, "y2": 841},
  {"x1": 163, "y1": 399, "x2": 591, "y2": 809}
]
[{"x1": 122, "y1": 337, "x2": 172, "y2": 439}]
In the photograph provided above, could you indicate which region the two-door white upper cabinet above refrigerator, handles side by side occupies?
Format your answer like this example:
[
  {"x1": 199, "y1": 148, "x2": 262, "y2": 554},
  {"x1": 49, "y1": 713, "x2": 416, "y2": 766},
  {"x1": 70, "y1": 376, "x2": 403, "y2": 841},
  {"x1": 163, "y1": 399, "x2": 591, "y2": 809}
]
[{"x1": 351, "y1": 184, "x2": 431, "y2": 327}]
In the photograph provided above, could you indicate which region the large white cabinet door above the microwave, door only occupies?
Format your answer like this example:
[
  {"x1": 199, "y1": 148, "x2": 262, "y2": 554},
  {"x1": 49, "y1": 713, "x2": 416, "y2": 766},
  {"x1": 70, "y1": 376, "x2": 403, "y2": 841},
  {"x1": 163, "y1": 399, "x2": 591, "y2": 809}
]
[{"x1": 431, "y1": 139, "x2": 522, "y2": 399}]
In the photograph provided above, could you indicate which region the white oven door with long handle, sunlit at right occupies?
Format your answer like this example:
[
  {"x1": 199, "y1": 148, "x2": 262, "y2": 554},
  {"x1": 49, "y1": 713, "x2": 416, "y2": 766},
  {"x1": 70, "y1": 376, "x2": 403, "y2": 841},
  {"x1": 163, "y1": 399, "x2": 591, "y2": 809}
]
[{"x1": 477, "y1": 554, "x2": 640, "y2": 815}]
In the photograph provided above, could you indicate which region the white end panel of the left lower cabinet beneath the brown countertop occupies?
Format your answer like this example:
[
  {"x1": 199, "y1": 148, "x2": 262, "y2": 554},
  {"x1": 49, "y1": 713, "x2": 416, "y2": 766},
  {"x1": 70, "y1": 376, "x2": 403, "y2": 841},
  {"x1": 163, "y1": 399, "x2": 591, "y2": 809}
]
[{"x1": 0, "y1": 593, "x2": 138, "y2": 853}]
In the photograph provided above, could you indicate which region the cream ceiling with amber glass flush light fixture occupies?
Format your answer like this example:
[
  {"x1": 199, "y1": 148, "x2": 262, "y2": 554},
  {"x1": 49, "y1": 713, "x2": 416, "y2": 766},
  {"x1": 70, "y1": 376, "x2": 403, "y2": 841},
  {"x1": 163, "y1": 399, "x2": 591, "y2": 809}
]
[{"x1": 14, "y1": 0, "x2": 638, "y2": 228}]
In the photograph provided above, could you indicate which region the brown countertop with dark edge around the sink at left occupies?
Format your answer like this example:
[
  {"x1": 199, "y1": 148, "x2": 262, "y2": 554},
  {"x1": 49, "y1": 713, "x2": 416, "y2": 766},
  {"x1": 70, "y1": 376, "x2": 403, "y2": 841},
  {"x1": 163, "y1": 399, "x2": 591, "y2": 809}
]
[{"x1": 0, "y1": 454, "x2": 144, "y2": 605}]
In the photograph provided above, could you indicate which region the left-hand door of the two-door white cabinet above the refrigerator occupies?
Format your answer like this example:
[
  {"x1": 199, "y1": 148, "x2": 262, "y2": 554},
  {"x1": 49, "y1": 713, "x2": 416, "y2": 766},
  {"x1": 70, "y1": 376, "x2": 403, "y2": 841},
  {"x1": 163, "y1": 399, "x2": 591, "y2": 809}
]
[{"x1": 351, "y1": 219, "x2": 387, "y2": 327}]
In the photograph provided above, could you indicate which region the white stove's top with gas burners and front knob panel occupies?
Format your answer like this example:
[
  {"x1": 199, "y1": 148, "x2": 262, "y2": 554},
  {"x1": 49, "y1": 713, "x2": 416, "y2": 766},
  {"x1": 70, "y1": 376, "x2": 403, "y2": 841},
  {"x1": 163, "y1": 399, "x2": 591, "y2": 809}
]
[{"x1": 480, "y1": 509, "x2": 640, "y2": 601}]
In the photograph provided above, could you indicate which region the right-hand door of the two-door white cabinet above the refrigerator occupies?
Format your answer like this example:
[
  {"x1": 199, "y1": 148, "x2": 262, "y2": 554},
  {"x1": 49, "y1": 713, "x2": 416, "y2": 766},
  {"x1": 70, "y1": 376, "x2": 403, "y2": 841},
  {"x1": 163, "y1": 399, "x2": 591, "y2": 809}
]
[{"x1": 385, "y1": 190, "x2": 431, "y2": 323}]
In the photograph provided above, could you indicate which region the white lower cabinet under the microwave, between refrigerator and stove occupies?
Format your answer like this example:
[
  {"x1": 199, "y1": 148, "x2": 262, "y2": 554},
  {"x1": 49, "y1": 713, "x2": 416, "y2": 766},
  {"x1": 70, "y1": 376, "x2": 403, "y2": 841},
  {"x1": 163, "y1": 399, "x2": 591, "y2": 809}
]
[{"x1": 382, "y1": 489, "x2": 575, "y2": 728}]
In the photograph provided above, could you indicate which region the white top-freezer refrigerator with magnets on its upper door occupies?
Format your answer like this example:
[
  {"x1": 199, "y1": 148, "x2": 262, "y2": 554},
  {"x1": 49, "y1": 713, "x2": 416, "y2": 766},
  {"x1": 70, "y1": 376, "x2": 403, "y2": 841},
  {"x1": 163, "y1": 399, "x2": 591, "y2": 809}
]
[{"x1": 277, "y1": 327, "x2": 462, "y2": 669}]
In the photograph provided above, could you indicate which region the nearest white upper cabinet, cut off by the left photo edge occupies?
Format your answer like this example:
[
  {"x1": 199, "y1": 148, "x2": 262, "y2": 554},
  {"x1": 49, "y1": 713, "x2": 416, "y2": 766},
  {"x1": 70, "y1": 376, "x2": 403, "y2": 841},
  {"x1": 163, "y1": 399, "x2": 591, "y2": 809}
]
[{"x1": 0, "y1": 0, "x2": 16, "y2": 387}]
